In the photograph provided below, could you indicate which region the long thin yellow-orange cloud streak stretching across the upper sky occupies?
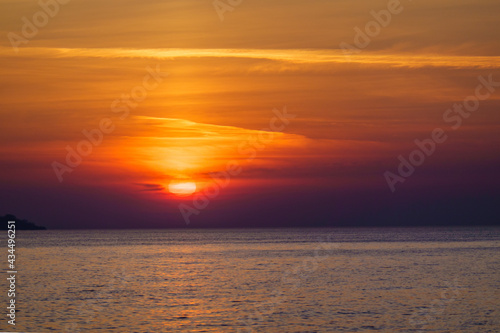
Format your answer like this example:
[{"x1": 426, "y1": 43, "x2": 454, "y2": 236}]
[{"x1": 0, "y1": 47, "x2": 500, "y2": 68}]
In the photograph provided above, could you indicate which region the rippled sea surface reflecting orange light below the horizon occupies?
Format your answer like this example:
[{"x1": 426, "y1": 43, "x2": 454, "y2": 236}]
[{"x1": 0, "y1": 227, "x2": 500, "y2": 333}]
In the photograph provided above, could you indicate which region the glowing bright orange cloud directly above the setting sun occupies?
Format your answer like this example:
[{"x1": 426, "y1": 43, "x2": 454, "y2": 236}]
[{"x1": 103, "y1": 116, "x2": 309, "y2": 184}]
